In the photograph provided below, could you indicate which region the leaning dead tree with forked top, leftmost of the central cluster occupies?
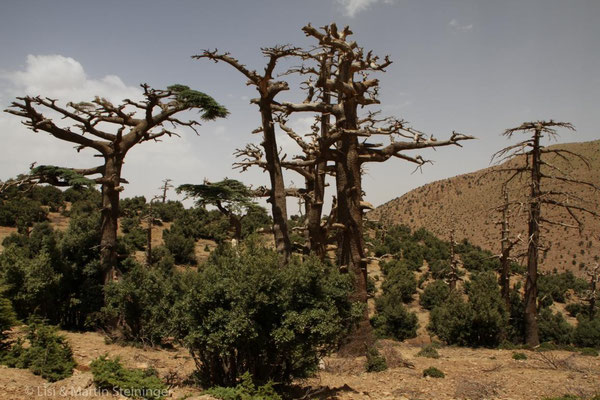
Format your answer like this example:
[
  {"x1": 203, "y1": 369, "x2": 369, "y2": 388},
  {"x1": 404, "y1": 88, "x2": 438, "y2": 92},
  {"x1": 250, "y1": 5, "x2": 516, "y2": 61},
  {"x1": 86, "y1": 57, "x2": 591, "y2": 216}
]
[{"x1": 192, "y1": 46, "x2": 298, "y2": 264}]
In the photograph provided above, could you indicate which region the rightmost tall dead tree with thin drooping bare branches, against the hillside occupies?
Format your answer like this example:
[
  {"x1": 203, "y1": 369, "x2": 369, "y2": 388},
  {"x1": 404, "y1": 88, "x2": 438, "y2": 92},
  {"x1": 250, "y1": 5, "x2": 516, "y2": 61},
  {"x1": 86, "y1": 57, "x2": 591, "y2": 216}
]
[{"x1": 492, "y1": 120, "x2": 598, "y2": 346}]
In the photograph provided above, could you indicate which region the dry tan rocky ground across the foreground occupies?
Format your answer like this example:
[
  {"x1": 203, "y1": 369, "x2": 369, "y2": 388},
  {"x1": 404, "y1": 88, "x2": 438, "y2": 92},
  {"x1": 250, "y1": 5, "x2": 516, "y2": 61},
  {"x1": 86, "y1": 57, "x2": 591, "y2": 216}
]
[{"x1": 0, "y1": 332, "x2": 600, "y2": 400}]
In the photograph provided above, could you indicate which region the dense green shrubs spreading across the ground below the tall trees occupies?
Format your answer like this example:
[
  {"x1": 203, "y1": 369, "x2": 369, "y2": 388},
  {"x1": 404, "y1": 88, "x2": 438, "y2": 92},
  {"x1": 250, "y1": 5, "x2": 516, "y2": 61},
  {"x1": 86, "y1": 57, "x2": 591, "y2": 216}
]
[{"x1": 0, "y1": 187, "x2": 600, "y2": 390}]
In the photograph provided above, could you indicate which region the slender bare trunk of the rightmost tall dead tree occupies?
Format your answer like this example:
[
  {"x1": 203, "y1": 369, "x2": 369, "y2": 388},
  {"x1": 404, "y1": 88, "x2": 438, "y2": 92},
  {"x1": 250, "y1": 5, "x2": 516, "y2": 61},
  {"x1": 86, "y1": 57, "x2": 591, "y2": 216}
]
[{"x1": 525, "y1": 129, "x2": 541, "y2": 346}]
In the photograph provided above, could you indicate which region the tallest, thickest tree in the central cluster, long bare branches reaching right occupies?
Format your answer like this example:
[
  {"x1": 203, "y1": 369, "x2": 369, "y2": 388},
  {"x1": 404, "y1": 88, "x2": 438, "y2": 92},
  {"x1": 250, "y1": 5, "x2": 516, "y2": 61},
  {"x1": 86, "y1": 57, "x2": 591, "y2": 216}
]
[{"x1": 277, "y1": 24, "x2": 472, "y2": 351}]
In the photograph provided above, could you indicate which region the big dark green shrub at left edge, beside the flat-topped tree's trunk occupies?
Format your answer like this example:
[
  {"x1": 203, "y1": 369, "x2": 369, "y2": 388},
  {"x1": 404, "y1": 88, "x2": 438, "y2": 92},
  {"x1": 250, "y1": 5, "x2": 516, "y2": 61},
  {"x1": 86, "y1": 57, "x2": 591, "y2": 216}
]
[{"x1": 0, "y1": 209, "x2": 103, "y2": 329}]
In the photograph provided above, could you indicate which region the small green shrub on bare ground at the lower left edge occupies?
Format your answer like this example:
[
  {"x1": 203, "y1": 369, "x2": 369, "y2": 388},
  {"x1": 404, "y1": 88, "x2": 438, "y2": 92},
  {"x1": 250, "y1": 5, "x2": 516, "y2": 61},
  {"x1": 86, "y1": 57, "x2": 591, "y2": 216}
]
[{"x1": 2, "y1": 322, "x2": 75, "y2": 382}]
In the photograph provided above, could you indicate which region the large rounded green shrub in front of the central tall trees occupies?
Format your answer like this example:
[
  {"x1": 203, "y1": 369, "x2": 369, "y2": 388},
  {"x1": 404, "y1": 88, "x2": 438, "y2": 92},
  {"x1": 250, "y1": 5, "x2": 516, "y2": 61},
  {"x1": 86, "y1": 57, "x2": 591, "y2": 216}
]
[{"x1": 179, "y1": 241, "x2": 362, "y2": 386}]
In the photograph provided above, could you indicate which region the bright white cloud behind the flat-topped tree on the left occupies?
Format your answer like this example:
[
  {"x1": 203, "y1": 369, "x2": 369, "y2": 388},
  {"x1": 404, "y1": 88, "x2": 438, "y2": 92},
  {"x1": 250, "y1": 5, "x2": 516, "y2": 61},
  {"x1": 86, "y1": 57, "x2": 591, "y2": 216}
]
[{"x1": 0, "y1": 55, "x2": 209, "y2": 197}]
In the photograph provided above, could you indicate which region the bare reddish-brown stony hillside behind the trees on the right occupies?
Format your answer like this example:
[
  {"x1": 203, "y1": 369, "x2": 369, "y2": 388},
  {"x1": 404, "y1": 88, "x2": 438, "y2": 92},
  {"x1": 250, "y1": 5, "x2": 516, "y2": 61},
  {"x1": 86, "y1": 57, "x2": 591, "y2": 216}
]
[{"x1": 369, "y1": 140, "x2": 600, "y2": 272}]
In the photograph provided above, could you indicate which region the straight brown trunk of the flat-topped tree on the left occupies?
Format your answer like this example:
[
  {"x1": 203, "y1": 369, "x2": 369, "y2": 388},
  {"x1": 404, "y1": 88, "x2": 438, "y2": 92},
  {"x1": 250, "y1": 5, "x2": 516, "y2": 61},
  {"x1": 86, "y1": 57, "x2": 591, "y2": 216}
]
[{"x1": 100, "y1": 155, "x2": 122, "y2": 284}]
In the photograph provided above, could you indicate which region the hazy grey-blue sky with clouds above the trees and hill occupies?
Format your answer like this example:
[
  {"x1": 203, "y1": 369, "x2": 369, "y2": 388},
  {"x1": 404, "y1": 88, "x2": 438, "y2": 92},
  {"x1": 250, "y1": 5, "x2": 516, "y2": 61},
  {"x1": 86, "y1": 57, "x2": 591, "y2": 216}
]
[{"x1": 0, "y1": 0, "x2": 600, "y2": 211}]
